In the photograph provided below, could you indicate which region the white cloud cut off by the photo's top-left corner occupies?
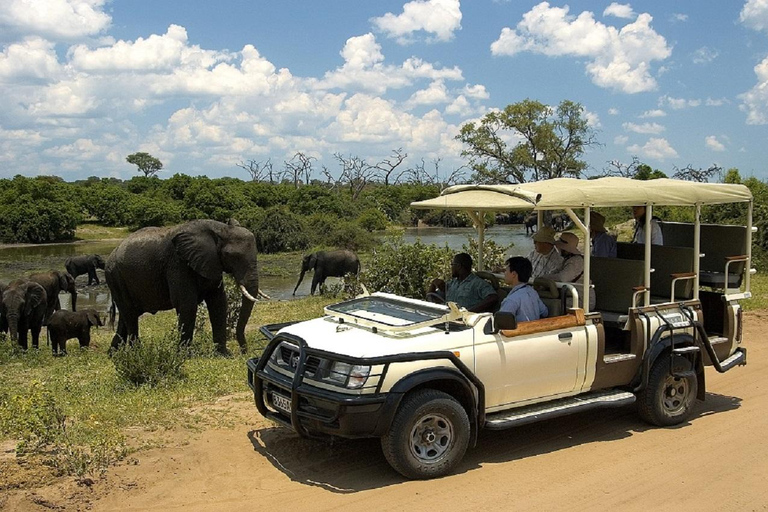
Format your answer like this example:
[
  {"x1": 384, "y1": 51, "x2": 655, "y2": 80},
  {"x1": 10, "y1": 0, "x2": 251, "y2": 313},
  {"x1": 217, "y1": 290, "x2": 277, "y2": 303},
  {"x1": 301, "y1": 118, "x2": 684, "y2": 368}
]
[{"x1": 0, "y1": 0, "x2": 112, "y2": 40}]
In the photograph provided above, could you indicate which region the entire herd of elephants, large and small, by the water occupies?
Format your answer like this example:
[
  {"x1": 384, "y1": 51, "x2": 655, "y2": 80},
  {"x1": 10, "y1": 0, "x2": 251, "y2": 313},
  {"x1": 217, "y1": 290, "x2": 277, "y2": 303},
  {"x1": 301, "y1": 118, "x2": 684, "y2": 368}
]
[{"x1": 0, "y1": 220, "x2": 360, "y2": 355}]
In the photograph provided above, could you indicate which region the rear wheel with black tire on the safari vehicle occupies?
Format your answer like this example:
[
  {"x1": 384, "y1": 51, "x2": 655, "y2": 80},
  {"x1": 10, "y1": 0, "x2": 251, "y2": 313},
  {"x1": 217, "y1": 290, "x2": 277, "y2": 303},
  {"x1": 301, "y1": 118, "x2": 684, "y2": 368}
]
[{"x1": 637, "y1": 354, "x2": 699, "y2": 427}]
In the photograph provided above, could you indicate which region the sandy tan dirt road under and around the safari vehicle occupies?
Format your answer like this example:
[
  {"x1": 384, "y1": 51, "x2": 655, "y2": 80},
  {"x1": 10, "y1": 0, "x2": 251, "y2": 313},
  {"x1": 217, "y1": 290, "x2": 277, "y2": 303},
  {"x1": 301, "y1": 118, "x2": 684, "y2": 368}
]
[{"x1": 0, "y1": 311, "x2": 768, "y2": 511}]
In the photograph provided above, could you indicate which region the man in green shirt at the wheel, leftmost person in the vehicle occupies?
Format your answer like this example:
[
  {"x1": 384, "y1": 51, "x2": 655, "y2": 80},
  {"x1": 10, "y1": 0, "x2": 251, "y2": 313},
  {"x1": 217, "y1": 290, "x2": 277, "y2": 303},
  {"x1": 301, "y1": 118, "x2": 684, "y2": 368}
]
[{"x1": 427, "y1": 252, "x2": 499, "y2": 313}]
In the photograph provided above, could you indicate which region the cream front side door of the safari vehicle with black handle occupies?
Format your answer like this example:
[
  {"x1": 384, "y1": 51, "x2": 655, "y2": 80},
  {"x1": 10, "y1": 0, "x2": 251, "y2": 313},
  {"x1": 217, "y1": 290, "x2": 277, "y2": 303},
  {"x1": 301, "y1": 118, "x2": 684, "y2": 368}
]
[{"x1": 475, "y1": 319, "x2": 588, "y2": 409}]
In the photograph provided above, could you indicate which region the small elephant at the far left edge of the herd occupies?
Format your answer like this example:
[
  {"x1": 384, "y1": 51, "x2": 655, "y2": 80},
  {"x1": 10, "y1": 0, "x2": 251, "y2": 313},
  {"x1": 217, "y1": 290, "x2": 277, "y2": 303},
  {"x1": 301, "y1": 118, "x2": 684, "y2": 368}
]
[{"x1": 0, "y1": 279, "x2": 48, "y2": 350}]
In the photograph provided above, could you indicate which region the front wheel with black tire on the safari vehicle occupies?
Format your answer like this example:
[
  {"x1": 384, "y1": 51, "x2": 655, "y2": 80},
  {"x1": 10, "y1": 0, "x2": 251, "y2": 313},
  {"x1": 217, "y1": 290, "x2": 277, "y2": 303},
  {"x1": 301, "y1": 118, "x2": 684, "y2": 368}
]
[{"x1": 381, "y1": 389, "x2": 470, "y2": 479}]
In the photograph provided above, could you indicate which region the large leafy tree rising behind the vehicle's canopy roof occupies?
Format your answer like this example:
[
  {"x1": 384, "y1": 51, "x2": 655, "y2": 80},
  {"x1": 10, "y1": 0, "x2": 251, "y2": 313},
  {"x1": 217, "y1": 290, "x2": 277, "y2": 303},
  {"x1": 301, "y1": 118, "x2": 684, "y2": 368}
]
[{"x1": 456, "y1": 99, "x2": 597, "y2": 183}]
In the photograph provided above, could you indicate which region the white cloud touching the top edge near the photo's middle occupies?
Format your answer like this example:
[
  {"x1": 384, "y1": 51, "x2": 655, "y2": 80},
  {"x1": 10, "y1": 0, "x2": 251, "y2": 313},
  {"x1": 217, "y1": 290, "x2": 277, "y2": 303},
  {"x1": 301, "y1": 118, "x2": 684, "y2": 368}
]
[{"x1": 371, "y1": 0, "x2": 461, "y2": 44}]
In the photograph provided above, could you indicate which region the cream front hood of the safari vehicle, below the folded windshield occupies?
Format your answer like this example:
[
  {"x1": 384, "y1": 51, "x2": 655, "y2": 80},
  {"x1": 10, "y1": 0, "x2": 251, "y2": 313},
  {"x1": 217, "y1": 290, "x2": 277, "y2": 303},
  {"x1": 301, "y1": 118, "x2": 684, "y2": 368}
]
[{"x1": 272, "y1": 317, "x2": 473, "y2": 357}]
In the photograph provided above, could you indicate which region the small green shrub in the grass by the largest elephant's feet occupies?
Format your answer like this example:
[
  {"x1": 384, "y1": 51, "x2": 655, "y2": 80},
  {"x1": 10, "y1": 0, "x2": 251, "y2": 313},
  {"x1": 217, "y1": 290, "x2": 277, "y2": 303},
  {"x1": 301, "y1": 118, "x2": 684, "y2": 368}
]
[{"x1": 112, "y1": 328, "x2": 186, "y2": 387}]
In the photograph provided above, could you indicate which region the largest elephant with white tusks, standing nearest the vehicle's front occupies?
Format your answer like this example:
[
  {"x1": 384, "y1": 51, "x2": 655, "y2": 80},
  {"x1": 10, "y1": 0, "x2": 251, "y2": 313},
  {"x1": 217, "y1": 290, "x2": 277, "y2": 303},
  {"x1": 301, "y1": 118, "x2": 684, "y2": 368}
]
[{"x1": 105, "y1": 220, "x2": 259, "y2": 354}]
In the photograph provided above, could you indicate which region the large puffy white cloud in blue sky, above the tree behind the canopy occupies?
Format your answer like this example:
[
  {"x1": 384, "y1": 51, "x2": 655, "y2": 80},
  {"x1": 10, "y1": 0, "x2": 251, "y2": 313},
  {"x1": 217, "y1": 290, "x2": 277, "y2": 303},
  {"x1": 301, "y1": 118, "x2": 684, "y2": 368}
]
[{"x1": 491, "y1": 2, "x2": 672, "y2": 94}]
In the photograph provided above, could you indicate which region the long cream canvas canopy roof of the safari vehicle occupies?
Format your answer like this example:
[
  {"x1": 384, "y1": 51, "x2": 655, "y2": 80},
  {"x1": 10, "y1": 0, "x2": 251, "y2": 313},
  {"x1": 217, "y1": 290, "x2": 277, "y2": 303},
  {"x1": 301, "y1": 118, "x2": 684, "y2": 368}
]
[{"x1": 411, "y1": 177, "x2": 752, "y2": 211}]
